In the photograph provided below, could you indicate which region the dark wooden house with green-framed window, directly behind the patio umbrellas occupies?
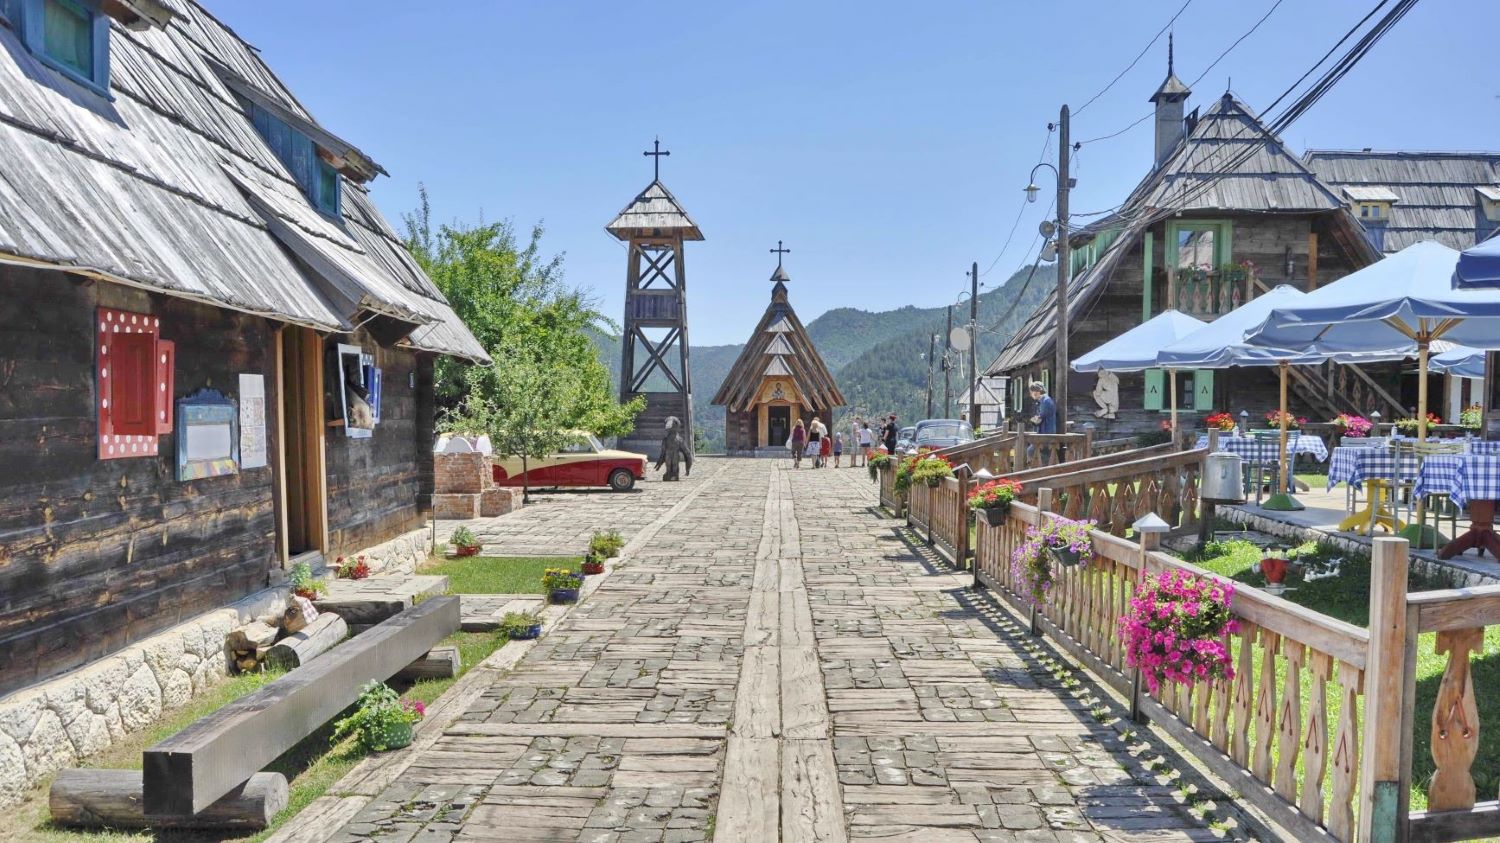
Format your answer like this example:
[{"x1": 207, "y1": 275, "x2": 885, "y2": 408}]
[{"x1": 987, "y1": 58, "x2": 1401, "y2": 435}]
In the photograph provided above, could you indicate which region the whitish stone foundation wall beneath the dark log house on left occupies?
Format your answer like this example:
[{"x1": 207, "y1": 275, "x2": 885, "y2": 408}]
[{"x1": 0, "y1": 530, "x2": 432, "y2": 810}]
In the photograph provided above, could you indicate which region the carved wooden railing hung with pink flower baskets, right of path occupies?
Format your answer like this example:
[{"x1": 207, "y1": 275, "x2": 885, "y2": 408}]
[{"x1": 975, "y1": 489, "x2": 1380, "y2": 842}]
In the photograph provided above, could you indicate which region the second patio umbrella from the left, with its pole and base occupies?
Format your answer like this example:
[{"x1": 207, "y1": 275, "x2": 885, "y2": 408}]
[{"x1": 1157, "y1": 285, "x2": 1328, "y2": 510}]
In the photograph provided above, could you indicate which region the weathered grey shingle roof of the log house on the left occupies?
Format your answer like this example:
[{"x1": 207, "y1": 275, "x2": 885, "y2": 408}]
[{"x1": 0, "y1": 0, "x2": 488, "y2": 360}]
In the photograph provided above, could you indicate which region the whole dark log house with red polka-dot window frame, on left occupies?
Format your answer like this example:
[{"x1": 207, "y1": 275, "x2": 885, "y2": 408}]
[{"x1": 0, "y1": 0, "x2": 488, "y2": 693}]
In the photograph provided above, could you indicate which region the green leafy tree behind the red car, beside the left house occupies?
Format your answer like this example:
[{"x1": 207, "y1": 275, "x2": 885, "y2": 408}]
[{"x1": 402, "y1": 188, "x2": 645, "y2": 435}]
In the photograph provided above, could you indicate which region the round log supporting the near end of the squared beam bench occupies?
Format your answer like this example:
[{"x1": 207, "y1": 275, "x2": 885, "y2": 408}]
[{"x1": 48, "y1": 770, "x2": 287, "y2": 830}]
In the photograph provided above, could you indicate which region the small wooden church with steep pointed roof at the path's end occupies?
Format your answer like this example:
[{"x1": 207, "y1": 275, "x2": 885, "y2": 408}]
[{"x1": 714, "y1": 245, "x2": 845, "y2": 456}]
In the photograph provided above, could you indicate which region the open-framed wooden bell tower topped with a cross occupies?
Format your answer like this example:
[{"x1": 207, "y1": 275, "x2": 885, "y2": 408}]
[{"x1": 605, "y1": 140, "x2": 704, "y2": 456}]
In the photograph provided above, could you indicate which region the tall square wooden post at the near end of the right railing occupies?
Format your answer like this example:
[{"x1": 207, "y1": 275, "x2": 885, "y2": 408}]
[{"x1": 1359, "y1": 537, "x2": 1412, "y2": 843}]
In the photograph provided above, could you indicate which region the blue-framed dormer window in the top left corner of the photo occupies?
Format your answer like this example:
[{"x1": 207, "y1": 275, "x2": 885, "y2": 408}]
[{"x1": 13, "y1": 0, "x2": 110, "y2": 95}]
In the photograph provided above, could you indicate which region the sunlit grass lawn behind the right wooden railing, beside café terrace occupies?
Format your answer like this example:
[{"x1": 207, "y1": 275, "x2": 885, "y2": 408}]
[{"x1": 1193, "y1": 542, "x2": 1500, "y2": 810}]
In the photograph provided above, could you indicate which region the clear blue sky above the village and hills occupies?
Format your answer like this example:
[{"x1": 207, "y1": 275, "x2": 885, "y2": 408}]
[{"x1": 207, "y1": 0, "x2": 1500, "y2": 345}]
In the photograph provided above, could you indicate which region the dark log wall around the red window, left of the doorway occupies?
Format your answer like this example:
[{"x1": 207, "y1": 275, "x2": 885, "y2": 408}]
[{"x1": 0, "y1": 267, "x2": 276, "y2": 693}]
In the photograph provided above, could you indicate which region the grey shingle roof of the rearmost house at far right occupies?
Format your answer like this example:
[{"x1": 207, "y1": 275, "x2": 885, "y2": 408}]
[{"x1": 1304, "y1": 150, "x2": 1500, "y2": 254}]
